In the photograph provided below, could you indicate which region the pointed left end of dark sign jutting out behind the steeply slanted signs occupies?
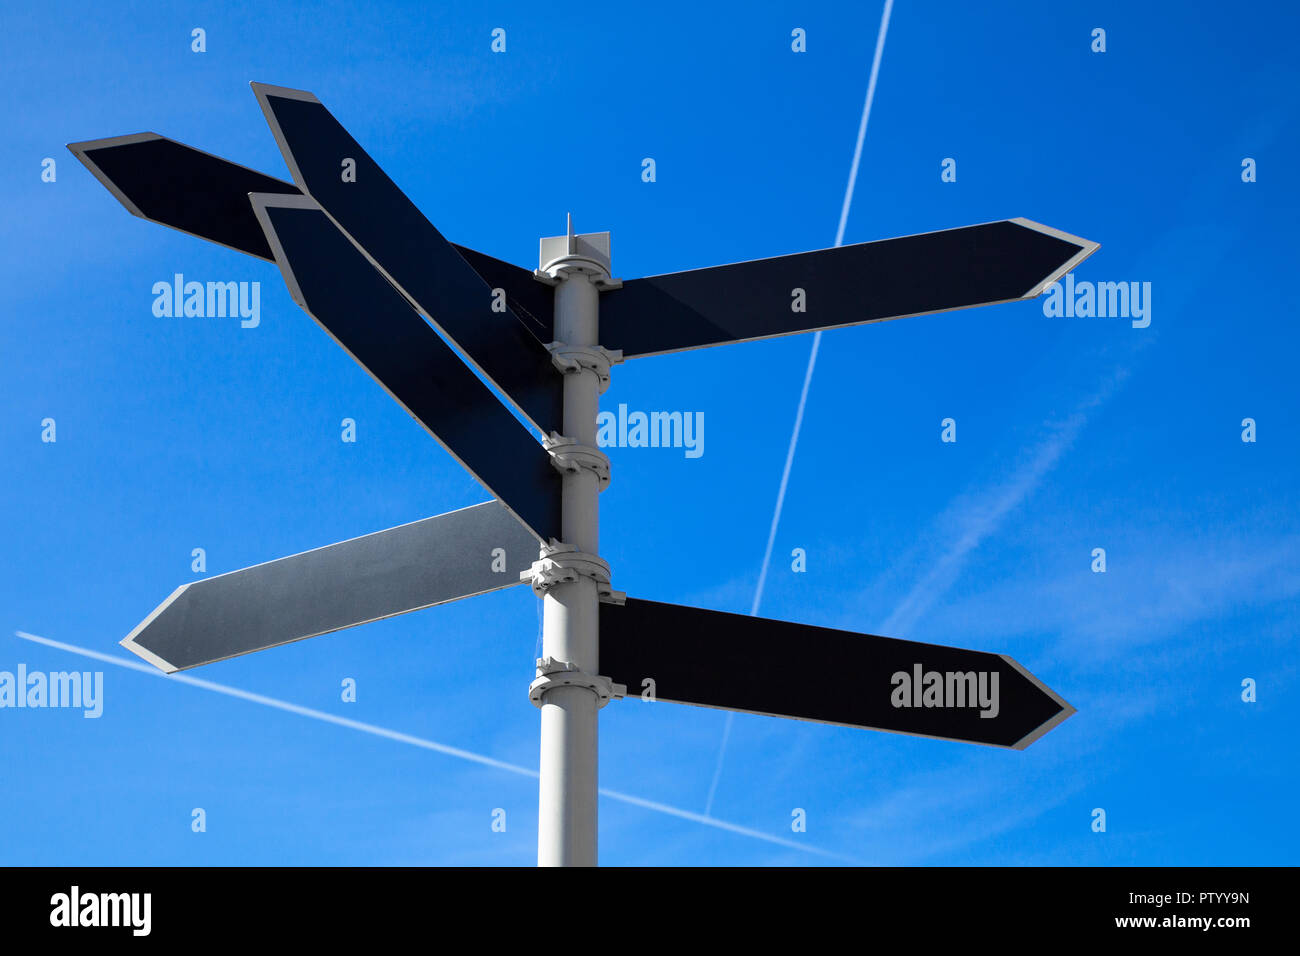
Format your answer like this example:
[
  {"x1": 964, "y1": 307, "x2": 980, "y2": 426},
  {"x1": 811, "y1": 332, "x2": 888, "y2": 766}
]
[{"x1": 68, "y1": 133, "x2": 300, "y2": 260}]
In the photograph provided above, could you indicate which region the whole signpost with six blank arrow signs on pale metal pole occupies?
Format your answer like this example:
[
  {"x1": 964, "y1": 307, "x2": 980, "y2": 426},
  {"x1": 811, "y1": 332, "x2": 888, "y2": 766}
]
[{"x1": 69, "y1": 83, "x2": 1097, "y2": 865}]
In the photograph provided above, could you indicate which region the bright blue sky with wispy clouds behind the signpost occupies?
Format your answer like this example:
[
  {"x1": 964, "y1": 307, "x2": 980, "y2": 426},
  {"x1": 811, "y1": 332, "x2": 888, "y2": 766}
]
[{"x1": 0, "y1": 0, "x2": 1300, "y2": 865}]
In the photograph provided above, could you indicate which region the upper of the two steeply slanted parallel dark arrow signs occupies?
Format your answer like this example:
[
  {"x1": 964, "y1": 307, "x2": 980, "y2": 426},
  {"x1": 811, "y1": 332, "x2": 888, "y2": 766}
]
[{"x1": 252, "y1": 83, "x2": 564, "y2": 434}]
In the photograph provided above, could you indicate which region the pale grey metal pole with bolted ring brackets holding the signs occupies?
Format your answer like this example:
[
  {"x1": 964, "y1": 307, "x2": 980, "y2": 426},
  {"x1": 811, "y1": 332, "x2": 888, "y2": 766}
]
[{"x1": 534, "y1": 222, "x2": 608, "y2": 866}]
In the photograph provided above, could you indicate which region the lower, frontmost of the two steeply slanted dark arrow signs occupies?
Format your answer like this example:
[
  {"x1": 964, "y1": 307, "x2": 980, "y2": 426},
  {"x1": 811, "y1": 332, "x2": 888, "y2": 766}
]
[{"x1": 252, "y1": 194, "x2": 560, "y2": 541}]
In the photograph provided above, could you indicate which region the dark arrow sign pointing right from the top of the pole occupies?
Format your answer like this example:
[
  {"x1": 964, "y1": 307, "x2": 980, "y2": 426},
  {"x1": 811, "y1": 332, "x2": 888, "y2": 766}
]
[{"x1": 601, "y1": 219, "x2": 1097, "y2": 358}]
